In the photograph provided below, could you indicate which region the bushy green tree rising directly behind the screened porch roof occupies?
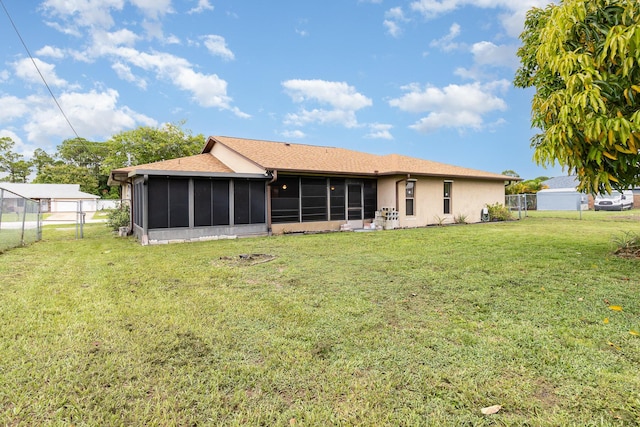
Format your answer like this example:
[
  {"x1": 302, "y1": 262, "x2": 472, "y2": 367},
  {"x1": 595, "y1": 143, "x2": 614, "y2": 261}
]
[{"x1": 102, "y1": 122, "x2": 204, "y2": 174}]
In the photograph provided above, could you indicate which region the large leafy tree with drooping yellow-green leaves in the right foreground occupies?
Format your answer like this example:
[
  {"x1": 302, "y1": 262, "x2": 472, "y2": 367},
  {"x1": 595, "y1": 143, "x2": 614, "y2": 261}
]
[{"x1": 514, "y1": 0, "x2": 640, "y2": 193}]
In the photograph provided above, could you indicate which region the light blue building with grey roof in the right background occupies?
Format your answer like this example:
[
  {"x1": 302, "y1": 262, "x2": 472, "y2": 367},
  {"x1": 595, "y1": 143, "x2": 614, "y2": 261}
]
[{"x1": 537, "y1": 175, "x2": 593, "y2": 211}]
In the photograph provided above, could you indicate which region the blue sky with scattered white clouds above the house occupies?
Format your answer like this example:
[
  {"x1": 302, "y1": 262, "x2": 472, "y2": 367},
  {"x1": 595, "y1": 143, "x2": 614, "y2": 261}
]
[{"x1": 0, "y1": 0, "x2": 563, "y2": 179}]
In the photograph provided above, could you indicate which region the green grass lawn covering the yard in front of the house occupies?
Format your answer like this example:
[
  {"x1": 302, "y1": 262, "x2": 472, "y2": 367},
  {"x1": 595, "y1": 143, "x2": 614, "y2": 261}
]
[{"x1": 0, "y1": 216, "x2": 640, "y2": 426}]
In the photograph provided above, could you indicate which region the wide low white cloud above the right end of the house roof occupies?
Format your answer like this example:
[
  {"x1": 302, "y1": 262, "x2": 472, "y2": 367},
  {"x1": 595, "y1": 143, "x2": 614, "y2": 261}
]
[{"x1": 389, "y1": 80, "x2": 510, "y2": 133}]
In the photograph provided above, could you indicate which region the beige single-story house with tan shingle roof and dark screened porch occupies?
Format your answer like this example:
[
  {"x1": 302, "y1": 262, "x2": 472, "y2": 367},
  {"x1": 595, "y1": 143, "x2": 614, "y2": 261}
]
[{"x1": 109, "y1": 136, "x2": 512, "y2": 244}]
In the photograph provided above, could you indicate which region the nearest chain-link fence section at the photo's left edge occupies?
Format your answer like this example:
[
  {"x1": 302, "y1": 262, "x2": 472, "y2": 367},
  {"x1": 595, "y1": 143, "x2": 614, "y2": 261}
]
[{"x1": 0, "y1": 189, "x2": 42, "y2": 252}]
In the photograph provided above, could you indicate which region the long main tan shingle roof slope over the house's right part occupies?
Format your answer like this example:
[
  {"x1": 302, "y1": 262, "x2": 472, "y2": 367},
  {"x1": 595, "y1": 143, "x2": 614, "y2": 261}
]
[{"x1": 203, "y1": 136, "x2": 513, "y2": 180}]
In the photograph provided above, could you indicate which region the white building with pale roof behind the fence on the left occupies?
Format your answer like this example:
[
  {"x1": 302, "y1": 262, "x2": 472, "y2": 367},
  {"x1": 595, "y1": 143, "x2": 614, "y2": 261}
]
[{"x1": 0, "y1": 182, "x2": 99, "y2": 213}]
